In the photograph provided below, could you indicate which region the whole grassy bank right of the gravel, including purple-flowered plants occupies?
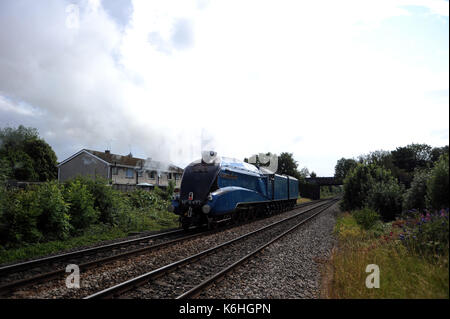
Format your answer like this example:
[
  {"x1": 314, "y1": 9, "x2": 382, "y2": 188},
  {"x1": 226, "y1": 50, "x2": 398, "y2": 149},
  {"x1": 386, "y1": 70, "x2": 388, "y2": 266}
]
[{"x1": 324, "y1": 209, "x2": 449, "y2": 299}]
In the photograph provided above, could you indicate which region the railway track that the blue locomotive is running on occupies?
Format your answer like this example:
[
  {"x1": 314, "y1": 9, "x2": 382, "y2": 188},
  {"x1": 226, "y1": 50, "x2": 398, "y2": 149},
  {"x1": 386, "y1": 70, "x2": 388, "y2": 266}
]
[{"x1": 0, "y1": 201, "x2": 321, "y2": 296}]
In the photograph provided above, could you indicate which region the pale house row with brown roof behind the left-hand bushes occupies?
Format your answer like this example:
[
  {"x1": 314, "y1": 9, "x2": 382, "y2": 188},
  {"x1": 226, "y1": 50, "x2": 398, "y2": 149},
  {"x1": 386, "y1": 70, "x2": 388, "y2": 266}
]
[{"x1": 58, "y1": 149, "x2": 183, "y2": 189}]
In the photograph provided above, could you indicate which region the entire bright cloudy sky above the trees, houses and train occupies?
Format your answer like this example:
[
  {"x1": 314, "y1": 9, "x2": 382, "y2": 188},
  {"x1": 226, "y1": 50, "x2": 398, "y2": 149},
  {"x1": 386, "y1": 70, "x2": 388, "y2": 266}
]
[{"x1": 0, "y1": 0, "x2": 449, "y2": 176}]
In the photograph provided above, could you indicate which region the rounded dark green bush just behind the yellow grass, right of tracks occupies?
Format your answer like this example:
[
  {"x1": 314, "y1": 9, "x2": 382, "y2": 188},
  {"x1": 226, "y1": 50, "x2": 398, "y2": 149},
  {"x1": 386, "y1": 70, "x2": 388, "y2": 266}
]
[{"x1": 366, "y1": 179, "x2": 403, "y2": 220}]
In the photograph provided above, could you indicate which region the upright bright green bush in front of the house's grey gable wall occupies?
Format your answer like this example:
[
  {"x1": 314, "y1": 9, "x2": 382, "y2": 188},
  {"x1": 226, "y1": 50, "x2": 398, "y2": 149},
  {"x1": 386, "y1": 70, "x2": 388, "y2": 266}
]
[{"x1": 64, "y1": 179, "x2": 99, "y2": 233}]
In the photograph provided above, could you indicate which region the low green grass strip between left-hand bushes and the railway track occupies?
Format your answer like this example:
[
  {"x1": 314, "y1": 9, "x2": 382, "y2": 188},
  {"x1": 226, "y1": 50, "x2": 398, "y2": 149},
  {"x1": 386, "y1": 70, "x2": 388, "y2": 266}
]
[{"x1": 0, "y1": 210, "x2": 179, "y2": 264}]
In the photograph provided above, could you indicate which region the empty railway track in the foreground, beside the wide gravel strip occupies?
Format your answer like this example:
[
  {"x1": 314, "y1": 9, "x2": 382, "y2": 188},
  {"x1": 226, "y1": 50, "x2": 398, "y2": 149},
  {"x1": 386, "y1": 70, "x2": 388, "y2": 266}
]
[{"x1": 85, "y1": 199, "x2": 338, "y2": 299}]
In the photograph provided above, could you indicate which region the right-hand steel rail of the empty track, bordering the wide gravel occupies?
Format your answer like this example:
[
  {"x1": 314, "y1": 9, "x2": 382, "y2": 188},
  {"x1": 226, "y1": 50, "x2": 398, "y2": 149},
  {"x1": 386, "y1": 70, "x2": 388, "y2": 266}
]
[{"x1": 175, "y1": 199, "x2": 339, "y2": 299}]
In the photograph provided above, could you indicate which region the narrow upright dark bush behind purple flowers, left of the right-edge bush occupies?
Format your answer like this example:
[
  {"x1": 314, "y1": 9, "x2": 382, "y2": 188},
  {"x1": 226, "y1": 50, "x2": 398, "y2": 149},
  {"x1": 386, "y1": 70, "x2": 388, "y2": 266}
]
[{"x1": 403, "y1": 170, "x2": 430, "y2": 210}]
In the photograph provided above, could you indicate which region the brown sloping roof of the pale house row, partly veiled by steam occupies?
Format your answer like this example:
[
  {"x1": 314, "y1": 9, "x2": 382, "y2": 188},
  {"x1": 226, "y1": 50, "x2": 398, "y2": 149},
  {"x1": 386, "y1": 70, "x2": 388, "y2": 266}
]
[{"x1": 58, "y1": 149, "x2": 183, "y2": 172}]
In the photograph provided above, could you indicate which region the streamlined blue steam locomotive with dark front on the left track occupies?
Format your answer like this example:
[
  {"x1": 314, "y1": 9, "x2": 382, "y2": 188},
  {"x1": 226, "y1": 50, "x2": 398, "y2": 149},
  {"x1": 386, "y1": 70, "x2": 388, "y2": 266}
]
[{"x1": 171, "y1": 153, "x2": 298, "y2": 229}]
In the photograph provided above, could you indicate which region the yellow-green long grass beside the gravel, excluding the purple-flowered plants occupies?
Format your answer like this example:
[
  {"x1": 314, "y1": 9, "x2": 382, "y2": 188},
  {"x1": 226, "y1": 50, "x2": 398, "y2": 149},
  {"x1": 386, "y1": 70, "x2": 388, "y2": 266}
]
[{"x1": 329, "y1": 213, "x2": 449, "y2": 299}]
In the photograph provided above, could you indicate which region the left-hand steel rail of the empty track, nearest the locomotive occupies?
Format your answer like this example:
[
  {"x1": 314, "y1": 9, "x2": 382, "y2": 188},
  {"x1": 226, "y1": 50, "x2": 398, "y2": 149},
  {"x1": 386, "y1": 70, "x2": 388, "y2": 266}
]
[{"x1": 83, "y1": 202, "x2": 334, "y2": 299}]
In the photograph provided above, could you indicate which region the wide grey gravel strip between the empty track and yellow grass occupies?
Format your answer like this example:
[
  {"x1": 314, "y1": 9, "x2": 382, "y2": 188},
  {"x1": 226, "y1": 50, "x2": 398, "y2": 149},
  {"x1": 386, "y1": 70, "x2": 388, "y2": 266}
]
[{"x1": 198, "y1": 204, "x2": 339, "y2": 299}]
